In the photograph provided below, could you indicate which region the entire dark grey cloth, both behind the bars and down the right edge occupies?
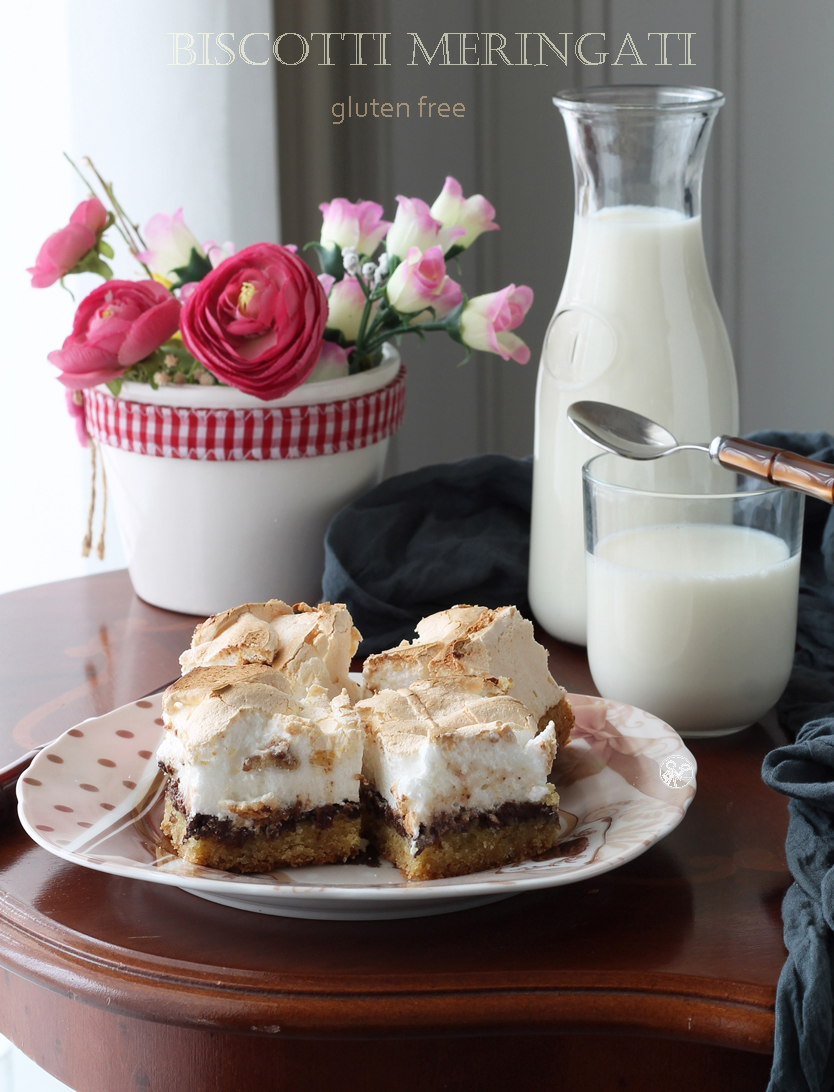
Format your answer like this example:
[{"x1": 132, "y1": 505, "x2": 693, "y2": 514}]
[{"x1": 324, "y1": 432, "x2": 834, "y2": 1092}]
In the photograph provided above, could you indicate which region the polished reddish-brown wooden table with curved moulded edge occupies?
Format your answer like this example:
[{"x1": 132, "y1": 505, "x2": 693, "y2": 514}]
[{"x1": 0, "y1": 576, "x2": 789, "y2": 1092}]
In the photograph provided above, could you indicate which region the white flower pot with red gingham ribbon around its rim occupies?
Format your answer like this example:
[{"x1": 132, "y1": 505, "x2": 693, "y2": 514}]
[{"x1": 85, "y1": 348, "x2": 405, "y2": 615}]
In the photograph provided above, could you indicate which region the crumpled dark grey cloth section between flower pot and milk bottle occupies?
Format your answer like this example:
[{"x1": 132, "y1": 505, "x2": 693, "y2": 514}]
[{"x1": 322, "y1": 455, "x2": 533, "y2": 656}]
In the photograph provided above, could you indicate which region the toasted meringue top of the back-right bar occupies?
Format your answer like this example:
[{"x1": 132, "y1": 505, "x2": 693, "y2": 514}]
[{"x1": 364, "y1": 606, "x2": 565, "y2": 726}]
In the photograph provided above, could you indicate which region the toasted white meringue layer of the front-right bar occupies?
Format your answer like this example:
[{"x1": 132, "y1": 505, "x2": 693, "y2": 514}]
[{"x1": 356, "y1": 676, "x2": 556, "y2": 838}]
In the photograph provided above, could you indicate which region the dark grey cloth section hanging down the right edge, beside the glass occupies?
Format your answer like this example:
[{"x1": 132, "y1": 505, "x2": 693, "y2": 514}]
[{"x1": 753, "y1": 432, "x2": 834, "y2": 1092}]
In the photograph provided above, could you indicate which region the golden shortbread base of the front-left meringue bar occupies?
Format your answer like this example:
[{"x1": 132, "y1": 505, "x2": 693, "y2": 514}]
[{"x1": 159, "y1": 797, "x2": 359, "y2": 873}]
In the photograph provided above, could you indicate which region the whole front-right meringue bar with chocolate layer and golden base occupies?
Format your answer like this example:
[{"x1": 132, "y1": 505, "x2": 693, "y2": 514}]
[{"x1": 356, "y1": 675, "x2": 559, "y2": 880}]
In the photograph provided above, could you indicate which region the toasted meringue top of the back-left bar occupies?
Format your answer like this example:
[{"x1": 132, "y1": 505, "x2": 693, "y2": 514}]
[{"x1": 179, "y1": 600, "x2": 361, "y2": 701}]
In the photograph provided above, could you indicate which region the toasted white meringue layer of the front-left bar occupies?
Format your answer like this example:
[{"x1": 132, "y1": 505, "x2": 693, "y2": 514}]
[{"x1": 157, "y1": 665, "x2": 362, "y2": 823}]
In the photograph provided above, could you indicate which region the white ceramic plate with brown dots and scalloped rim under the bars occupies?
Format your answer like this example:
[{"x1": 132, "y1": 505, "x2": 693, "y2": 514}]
[{"x1": 17, "y1": 695, "x2": 695, "y2": 919}]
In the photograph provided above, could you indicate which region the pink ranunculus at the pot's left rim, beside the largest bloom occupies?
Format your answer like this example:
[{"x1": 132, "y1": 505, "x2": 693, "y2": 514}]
[{"x1": 49, "y1": 281, "x2": 180, "y2": 390}]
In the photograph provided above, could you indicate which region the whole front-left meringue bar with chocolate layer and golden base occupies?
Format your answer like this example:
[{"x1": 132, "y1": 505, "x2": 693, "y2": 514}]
[{"x1": 157, "y1": 664, "x2": 362, "y2": 873}]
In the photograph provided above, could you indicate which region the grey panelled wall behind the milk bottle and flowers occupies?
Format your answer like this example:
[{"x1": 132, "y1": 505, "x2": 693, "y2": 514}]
[{"x1": 274, "y1": 0, "x2": 834, "y2": 472}]
